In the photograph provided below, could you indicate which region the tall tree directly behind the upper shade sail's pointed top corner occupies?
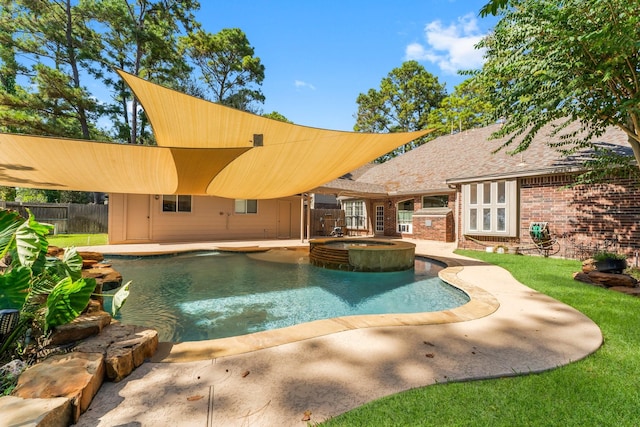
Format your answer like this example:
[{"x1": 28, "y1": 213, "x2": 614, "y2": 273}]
[{"x1": 83, "y1": 0, "x2": 200, "y2": 144}]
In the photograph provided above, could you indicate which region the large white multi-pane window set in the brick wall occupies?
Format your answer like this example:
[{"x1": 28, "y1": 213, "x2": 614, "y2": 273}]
[{"x1": 462, "y1": 181, "x2": 517, "y2": 236}]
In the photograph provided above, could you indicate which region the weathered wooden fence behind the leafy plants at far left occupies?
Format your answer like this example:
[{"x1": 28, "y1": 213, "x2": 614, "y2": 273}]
[{"x1": 0, "y1": 201, "x2": 109, "y2": 234}]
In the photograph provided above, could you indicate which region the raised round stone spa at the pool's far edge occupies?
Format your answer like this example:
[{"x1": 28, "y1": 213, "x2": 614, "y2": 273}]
[{"x1": 309, "y1": 238, "x2": 416, "y2": 271}]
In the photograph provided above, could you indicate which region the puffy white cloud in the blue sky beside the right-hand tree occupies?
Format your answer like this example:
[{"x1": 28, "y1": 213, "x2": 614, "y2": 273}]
[{"x1": 405, "y1": 13, "x2": 484, "y2": 74}]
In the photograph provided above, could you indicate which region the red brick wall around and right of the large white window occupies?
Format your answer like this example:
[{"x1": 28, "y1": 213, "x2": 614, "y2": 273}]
[{"x1": 458, "y1": 175, "x2": 640, "y2": 258}]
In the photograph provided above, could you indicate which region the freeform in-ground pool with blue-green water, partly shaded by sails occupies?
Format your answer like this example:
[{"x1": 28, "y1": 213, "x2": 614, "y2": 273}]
[{"x1": 105, "y1": 249, "x2": 469, "y2": 342}]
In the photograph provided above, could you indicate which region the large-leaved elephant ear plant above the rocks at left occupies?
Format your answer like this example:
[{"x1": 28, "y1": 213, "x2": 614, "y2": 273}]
[{"x1": 0, "y1": 209, "x2": 128, "y2": 359}]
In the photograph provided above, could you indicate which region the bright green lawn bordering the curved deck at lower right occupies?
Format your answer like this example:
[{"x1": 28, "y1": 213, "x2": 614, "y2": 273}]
[{"x1": 322, "y1": 251, "x2": 640, "y2": 427}]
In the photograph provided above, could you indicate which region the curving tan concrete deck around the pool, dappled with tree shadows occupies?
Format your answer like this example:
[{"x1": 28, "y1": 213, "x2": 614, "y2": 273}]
[{"x1": 72, "y1": 240, "x2": 602, "y2": 426}]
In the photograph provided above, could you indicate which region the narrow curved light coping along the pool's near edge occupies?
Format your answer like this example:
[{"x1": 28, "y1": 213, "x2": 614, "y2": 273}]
[{"x1": 145, "y1": 252, "x2": 500, "y2": 363}]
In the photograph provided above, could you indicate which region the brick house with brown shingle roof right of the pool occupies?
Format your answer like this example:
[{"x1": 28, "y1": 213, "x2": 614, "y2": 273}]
[{"x1": 318, "y1": 125, "x2": 640, "y2": 258}]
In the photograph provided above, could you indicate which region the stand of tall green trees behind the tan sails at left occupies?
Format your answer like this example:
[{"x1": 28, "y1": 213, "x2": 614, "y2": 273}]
[{"x1": 0, "y1": 0, "x2": 265, "y2": 201}]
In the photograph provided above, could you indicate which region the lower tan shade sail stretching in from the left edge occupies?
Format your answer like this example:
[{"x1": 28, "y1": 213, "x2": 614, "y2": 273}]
[{"x1": 0, "y1": 133, "x2": 178, "y2": 194}]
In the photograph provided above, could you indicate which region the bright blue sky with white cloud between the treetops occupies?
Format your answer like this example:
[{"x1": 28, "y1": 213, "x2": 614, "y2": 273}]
[{"x1": 197, "y1": 0, "x2": 496, "y2": 131}]
